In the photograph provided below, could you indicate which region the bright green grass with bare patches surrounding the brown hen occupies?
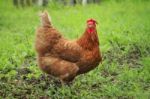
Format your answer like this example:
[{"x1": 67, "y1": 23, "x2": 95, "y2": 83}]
[{"x1": 0, "y1": 0, "x2": 150, "y2": 99}]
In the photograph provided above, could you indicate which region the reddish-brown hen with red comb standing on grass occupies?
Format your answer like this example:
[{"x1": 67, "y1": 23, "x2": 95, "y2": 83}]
[{"x1": 35, "y1": 11, "x2": 102, "y2": 83}]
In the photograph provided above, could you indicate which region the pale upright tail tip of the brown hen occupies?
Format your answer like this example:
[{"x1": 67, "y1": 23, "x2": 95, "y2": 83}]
[{"x1": 40, "y1": 11, "x2": 52, "y2": 27}]
